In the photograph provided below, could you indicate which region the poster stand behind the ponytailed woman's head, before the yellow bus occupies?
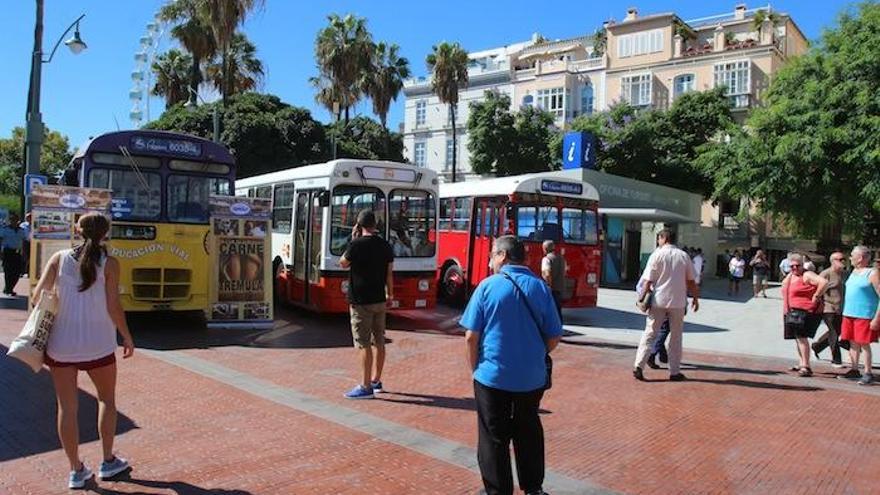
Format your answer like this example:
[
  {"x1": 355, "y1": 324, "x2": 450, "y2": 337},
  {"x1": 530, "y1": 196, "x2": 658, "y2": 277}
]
[{"x1": 28, "y1": 185, "x2": 112, "y2": 290}]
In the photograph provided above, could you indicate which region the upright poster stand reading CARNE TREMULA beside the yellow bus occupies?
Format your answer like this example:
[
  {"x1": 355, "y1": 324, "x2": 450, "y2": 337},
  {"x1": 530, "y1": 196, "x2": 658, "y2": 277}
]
[{"x1": 208, "y1": 196, "x2": 273, "y2": 328}]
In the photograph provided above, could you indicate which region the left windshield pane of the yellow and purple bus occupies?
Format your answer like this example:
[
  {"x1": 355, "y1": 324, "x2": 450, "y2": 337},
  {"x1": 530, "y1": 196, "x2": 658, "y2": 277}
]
[{"x1": 88, "y1": 168, "x2": 162, "y2": 220}]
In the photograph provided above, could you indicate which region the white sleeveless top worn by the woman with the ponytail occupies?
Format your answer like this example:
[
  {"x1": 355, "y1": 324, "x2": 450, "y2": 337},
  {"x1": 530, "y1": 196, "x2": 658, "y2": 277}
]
[{"x1": 46, "y1": 249, "x2": 116, "y2": 363}]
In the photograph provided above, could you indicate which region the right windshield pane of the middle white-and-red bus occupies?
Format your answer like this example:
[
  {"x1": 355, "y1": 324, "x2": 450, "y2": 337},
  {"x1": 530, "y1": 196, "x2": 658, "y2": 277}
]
[{"x1": 388, "y1": 189, "x2": 437, "y2": 258}]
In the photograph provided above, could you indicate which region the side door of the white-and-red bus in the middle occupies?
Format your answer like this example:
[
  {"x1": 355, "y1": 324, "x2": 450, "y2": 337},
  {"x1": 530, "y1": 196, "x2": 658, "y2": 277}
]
[{"x1": 290, "y1": 189, "x2": 324, "y2": 305}]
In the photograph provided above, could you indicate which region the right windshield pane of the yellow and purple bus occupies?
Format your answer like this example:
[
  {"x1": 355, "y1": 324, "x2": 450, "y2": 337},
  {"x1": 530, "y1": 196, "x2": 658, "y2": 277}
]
[{"x1": 168, "y1": 175, "x2": 230, "y2": 223}]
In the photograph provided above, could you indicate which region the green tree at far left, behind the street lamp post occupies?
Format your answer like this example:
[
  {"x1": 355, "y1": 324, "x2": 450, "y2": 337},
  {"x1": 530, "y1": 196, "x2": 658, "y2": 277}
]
[{"x1": 0, "y1": 127, "x2": 73, "y2": 196}]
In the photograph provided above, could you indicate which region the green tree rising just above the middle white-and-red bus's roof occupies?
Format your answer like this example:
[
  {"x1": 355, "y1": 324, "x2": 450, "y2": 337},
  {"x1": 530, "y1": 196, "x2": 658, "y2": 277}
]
[{"x1": 328, "y1": 115, "x2": 404, "y2": 162}]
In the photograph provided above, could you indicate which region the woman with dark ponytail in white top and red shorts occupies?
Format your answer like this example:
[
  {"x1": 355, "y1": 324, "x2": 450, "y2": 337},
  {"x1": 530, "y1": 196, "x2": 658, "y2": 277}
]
[{"x1": 33, "y1": 213, "x2": 134, "y2": 488}]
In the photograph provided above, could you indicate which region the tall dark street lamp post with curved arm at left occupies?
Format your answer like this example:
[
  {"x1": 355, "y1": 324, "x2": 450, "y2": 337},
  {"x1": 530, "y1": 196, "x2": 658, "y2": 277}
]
[{"x1": 22, "y1": 0, "x2": 86, "y2": 212}]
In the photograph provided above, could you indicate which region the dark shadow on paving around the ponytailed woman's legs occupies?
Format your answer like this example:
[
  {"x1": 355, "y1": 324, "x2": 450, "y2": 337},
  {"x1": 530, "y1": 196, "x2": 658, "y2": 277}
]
[{"x1": 0, "y1": 345, "x2": 137, "y2": 462}]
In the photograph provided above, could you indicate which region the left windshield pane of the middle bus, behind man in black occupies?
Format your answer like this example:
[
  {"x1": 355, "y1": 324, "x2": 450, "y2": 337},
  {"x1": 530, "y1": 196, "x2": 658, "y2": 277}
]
[{"x1": 330, "y1": 186, "x2": 385, "y2": 256}]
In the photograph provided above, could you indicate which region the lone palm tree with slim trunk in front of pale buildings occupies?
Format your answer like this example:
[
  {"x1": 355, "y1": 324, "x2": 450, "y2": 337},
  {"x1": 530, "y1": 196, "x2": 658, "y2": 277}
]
[{"x1": 425, "y1": 41, "x2": 468, "y2": 182}]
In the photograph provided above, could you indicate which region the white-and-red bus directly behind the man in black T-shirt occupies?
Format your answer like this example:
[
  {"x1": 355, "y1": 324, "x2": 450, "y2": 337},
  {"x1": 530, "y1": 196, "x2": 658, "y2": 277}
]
[{"x1": 236, "y1": 160, "x2": 438, "y2": 313}]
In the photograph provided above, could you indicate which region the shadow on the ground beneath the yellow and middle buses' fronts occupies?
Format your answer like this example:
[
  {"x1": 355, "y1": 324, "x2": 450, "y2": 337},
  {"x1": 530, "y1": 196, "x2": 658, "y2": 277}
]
[{"x1": 129, "y1": 308, "x2": 354, "y2": 351}]
